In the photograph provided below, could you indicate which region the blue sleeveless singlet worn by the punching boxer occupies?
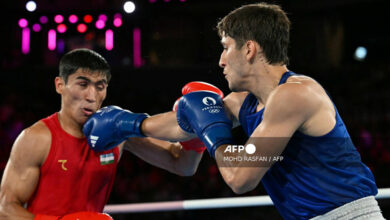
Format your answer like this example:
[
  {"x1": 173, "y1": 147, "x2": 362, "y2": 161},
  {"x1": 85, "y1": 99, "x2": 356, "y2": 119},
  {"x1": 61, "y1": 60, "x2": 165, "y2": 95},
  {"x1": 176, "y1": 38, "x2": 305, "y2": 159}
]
[{"x1": 239, "y1": 71, "x2": 378, "y2": 219}]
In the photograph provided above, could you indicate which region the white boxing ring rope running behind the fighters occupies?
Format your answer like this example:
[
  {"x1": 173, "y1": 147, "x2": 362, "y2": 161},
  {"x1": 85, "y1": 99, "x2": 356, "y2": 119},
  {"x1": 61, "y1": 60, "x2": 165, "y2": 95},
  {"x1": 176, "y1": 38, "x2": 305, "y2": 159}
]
[{"x1": 104, "y1": 188, "x2": 390, "y2": 214}]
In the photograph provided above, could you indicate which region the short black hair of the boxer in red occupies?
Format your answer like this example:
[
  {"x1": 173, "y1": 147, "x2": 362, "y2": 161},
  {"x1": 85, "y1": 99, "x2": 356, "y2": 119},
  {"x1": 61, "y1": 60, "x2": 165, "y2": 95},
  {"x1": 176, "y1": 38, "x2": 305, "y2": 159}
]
[{"x1": 59, "y1": 48, "x2": 111, "y2": 83}]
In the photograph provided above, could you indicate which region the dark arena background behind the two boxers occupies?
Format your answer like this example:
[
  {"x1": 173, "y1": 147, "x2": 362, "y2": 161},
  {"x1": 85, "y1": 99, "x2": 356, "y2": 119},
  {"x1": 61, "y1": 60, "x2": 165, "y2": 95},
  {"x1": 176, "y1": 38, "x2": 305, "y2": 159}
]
[{"x1": 0, "y1": 0, "x2": 390, "y2": 219}]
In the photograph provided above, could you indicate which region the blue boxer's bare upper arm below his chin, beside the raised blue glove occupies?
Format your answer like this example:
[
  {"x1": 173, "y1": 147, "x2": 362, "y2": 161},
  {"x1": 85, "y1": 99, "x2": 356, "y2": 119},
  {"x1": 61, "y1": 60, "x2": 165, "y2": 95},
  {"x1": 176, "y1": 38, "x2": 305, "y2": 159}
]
[{"x1": 223, "y1": 92, "x2": 248, "y2": 127}]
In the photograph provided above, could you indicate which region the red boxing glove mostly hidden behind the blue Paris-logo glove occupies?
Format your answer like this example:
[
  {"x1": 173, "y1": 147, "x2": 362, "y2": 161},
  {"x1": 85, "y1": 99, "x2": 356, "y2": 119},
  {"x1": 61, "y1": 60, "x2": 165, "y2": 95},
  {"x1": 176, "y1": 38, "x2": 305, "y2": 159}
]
[{"x1": 173, "y1": 81, "x2": 224, "y2": 154}]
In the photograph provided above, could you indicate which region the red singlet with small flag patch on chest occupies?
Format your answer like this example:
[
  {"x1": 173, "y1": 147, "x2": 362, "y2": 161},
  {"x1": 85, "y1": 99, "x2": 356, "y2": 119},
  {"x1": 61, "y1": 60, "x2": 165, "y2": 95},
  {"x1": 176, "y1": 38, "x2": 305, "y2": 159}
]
[{"x1": 27, "y1": 113, "x2": 119, "y2": 215}]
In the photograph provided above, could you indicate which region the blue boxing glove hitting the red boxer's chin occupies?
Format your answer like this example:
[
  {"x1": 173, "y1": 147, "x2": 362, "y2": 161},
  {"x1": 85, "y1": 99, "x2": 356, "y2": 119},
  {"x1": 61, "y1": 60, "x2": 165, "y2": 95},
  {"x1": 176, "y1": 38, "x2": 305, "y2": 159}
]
[{"x1": 83, "y1": 105, "x2": 148, "y2": 151}]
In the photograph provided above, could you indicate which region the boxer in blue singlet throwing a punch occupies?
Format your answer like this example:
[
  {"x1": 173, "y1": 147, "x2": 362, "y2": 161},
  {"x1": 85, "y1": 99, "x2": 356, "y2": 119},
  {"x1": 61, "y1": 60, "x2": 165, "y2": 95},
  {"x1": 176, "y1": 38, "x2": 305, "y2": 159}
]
[{"x1": 83, "y1": 3, "x2": 383, "y2": 220}]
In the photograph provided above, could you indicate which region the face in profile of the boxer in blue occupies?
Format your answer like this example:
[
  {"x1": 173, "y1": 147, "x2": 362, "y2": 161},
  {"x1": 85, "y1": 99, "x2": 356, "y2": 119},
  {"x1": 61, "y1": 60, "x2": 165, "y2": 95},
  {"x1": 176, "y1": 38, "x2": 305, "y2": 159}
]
[{"x1": 219, "y1": 36, "x2": 246, "y2": 92}]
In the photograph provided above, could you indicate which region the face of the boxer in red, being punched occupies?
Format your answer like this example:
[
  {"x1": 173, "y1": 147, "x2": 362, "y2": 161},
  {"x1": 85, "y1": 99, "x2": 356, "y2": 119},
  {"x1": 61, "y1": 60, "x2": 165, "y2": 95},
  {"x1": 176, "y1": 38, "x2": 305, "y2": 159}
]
[{"x1": 56, "y1": 69, "x2": 107, "y2": 125}]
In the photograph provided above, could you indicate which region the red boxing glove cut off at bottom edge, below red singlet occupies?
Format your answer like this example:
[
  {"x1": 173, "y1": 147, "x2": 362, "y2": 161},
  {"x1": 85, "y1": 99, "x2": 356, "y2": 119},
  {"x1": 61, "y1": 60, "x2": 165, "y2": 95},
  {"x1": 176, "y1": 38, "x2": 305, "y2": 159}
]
[{"x1": 34, "y1": 212, "x2": 113, "y2": 220}]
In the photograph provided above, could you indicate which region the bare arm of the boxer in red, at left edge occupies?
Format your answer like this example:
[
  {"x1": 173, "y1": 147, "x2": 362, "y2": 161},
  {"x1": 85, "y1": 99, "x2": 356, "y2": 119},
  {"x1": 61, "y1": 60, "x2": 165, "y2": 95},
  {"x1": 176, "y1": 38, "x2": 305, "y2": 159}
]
[{"x1": 0, "y1": 123, "x2": 51, "y2": 219}]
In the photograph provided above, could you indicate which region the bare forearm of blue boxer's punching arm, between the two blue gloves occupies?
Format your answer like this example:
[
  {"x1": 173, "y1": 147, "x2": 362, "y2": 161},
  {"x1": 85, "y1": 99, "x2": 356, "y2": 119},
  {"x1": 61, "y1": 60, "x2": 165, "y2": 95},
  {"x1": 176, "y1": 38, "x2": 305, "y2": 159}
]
[{"x1": 141, "y1": 111, "x2": 195, "y2": 141}]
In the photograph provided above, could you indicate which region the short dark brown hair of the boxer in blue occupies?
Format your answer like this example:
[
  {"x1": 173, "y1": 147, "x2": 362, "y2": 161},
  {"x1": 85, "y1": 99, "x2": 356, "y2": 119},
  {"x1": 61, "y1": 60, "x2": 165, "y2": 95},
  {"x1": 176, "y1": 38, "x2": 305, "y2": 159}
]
[{"x1": 217, "y1": 3, "x2": 290, "y2": 64}]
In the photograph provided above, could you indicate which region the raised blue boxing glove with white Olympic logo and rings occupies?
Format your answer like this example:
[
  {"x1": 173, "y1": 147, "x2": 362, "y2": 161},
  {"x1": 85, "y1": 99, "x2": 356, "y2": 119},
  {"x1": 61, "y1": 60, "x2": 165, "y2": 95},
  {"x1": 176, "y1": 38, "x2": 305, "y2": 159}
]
[{"x1": 176, "y1": 91, "x2": 233, "y2": 158}]
